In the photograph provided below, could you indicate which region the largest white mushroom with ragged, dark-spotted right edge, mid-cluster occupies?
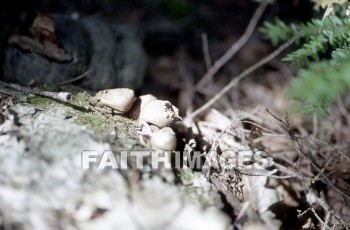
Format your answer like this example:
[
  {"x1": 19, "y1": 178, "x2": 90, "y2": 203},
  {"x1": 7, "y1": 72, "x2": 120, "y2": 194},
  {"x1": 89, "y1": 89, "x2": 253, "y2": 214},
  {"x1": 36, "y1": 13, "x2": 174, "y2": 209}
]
[{"x1": 139, "y1": 100, "x2": 181, "y2": 128}]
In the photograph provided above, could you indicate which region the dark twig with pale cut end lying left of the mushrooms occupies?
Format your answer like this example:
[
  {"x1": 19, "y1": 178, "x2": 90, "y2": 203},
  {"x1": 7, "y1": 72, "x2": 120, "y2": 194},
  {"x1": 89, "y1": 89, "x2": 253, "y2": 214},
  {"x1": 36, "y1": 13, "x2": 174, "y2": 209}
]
[{"x1": 0, "y1": 81, "x2": 73, "y2": 102}]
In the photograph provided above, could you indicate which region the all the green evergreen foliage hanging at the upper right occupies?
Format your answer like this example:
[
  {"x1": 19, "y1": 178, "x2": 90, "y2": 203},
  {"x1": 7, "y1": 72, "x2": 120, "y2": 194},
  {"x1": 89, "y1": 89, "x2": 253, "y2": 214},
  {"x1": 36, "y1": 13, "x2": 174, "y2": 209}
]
[{"x1": 260, "y1": 4, "x2": 350, "y2": 116}]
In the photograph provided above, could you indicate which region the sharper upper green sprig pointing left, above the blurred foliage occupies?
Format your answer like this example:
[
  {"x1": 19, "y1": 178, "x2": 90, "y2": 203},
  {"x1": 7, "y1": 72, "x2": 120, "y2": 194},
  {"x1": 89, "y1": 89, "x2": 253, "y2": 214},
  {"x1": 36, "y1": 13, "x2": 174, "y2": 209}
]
[{"x1": 260, "y1": 16, "x2": 350, "y2": 66}]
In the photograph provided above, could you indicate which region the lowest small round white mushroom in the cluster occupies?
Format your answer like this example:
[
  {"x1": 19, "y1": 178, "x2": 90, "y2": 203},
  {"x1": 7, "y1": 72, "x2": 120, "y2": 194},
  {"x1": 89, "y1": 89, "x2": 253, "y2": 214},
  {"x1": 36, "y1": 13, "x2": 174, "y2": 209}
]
[{"x1": 150, "y1": 127, "x2": 177, "y2": 151}]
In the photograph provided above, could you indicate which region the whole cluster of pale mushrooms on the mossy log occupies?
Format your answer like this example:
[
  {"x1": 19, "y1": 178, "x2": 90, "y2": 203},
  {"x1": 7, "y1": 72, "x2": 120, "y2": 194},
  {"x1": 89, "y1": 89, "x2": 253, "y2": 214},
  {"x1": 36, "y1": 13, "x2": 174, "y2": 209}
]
[{"x1": 90, "y1": 88, "x2": 181, "y2": 151}]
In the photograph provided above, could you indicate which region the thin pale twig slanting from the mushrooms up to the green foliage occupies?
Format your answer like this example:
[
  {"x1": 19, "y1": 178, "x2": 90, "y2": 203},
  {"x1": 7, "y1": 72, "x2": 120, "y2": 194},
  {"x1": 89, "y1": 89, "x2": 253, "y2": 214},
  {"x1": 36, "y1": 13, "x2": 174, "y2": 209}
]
[{"x1": 190, "y1": 41, "x2": 292, "y2": 118}]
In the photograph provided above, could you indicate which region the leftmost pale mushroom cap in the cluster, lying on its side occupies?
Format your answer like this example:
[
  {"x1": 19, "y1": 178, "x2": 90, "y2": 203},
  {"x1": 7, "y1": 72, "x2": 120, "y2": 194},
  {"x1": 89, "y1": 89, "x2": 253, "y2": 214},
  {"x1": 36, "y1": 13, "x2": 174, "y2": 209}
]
[{"x1": 95, "y1": 88, "x2": 135, "y2": 113}]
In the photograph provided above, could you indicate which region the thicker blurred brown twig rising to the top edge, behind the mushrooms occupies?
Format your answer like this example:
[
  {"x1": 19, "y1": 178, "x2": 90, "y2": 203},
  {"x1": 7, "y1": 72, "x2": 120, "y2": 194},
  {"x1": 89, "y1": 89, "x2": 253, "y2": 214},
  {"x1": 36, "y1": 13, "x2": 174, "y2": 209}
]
[{"x1": 195, "y1": 1, "x2": 268, "y2": 90}]
